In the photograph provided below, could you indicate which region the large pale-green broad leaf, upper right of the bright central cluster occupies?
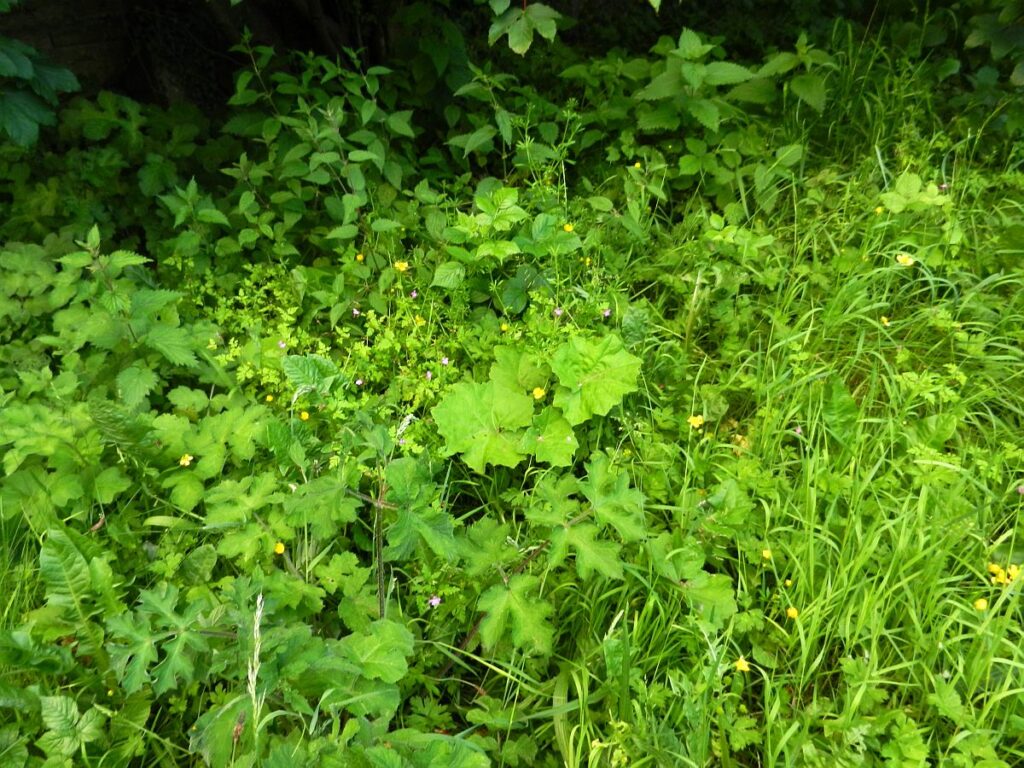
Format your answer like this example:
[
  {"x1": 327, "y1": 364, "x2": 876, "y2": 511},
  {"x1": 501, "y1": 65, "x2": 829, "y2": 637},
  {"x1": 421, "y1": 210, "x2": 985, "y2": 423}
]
[{"x1": 551, "y1": 335, "x2": 640, "y2": 425}]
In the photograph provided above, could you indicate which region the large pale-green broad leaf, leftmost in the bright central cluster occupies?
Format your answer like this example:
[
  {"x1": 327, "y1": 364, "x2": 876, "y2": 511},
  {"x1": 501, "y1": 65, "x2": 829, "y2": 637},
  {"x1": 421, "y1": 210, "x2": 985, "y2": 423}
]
[{"x1": 430, "y1": 382, "x2": 534, "y2": 473}]
